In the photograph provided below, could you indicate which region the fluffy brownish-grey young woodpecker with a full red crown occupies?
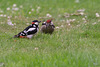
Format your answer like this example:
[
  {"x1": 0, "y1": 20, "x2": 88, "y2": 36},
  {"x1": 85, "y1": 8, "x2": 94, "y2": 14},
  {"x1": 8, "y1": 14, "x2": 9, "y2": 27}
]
[{"x1": 41, "y1": 20, "x2": 55, "y2": 34}]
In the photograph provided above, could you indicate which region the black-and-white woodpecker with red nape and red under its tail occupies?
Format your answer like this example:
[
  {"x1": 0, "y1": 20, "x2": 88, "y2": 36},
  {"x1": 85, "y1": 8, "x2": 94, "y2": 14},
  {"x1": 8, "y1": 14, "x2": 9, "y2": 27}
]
[{"x1": 14, "y1": 20, "x2": 41, "y2": 39}]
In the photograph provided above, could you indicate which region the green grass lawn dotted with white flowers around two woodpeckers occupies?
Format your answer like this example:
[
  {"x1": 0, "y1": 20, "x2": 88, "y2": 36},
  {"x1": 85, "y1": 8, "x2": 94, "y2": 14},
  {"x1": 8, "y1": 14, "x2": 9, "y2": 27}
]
[{"x1": 0, "y1": 0, "x2": 100, "y2": 67}]
